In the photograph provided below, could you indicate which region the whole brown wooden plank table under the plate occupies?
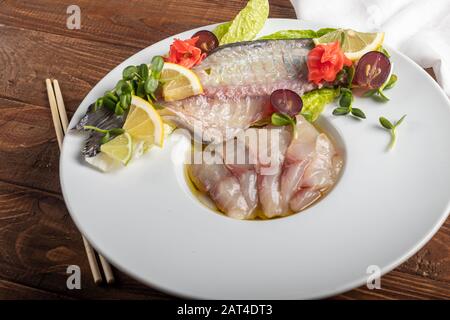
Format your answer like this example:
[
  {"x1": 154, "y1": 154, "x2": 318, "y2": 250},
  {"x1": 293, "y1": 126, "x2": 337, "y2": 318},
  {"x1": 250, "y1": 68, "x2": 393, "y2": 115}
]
[{"x1": 0, "y1": 0, "x2": 450, "y2": 299}]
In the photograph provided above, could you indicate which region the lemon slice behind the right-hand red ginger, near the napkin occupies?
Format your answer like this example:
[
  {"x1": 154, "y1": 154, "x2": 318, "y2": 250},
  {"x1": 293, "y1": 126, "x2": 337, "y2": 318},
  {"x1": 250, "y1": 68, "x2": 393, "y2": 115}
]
[{"x1": 314, "y1": 29, "x2": 384, "y2": 61}]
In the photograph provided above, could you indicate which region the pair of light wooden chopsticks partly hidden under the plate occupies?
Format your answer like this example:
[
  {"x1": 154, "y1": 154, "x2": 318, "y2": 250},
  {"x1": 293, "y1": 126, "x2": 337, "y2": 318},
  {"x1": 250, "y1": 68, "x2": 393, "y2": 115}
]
[{"x1": 45, "y1": 79, "x2": 114, "y2": 284}]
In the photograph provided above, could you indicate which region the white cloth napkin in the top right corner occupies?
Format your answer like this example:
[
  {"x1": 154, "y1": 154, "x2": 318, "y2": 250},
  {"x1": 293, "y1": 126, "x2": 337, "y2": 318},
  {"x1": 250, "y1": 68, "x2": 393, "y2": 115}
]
[{"x1": 291, "y1": 0, "x2": 450, "y2": 97}]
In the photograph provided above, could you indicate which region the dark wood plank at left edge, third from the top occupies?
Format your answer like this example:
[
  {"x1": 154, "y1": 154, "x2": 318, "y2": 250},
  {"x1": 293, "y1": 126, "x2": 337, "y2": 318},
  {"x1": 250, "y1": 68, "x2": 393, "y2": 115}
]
[{"x1": 0, "y1": 98, "x2": 61, "y2": 193}]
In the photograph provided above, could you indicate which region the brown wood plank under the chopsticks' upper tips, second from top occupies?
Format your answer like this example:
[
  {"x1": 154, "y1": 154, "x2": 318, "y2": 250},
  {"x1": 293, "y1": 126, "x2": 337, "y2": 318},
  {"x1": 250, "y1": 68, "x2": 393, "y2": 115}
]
[{"x1": 0, "y1": 25, "x2": 137, "y2": 111}]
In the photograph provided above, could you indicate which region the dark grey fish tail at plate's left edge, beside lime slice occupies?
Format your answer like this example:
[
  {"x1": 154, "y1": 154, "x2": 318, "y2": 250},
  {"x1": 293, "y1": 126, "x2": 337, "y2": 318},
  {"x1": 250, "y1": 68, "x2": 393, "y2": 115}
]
[{"x1": 72, "y1": 104, "x2": 127, "y2": 158}]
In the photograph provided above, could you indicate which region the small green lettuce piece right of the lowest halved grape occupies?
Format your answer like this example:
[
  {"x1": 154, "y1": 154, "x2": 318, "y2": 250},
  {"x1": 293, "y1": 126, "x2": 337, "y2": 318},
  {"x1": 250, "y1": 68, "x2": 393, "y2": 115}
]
[{"x1": 301, "y1": 88, "x2": 340, "y2": 122}]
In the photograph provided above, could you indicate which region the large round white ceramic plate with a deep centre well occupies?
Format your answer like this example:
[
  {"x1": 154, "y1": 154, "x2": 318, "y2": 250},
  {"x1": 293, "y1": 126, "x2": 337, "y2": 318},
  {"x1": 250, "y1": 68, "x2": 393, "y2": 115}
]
[{"x1": 60, "y1": 19, "x2": 450, "y2": 299}]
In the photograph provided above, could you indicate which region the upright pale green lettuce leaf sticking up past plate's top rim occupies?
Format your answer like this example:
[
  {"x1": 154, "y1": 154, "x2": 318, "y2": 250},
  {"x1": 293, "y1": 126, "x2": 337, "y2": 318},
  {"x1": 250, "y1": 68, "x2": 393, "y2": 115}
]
[{"x1": 214, "y1": 0, "x2": 269, "y2": 45}]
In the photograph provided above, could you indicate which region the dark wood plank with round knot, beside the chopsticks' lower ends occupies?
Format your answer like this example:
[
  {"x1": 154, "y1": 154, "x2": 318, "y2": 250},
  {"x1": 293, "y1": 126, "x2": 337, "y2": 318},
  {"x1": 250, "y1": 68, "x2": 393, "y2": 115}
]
[{"x1": 0, "y1": 182, "x2": 168, "y2": 299}]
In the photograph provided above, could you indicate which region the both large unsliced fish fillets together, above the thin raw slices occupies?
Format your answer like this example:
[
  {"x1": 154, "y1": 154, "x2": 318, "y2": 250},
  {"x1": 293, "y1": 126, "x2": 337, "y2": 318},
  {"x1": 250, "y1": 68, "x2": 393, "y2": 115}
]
[{"x1": 161, "y1": 39, "x2": 317, "y2": 143}]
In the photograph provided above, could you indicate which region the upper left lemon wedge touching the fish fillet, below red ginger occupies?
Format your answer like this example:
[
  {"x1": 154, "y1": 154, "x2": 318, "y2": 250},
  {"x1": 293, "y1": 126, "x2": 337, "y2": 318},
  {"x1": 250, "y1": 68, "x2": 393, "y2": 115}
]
[{"x1": 161, "y1": 62, "x2": 203, "y2": 101}]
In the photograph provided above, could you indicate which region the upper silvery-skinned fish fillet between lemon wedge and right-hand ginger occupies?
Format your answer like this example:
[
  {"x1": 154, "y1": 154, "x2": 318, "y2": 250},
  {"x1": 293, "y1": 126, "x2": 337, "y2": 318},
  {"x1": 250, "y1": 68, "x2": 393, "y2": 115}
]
[{"x1": 194, "y1": 39, "x2": 312, "y2": 94}]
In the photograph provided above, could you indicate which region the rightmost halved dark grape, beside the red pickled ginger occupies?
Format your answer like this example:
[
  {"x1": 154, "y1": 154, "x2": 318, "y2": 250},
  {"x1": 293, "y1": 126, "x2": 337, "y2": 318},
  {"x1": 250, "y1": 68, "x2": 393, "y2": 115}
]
[{"x1": 353, "y1": 51, "x2": 391, "y2": 90}]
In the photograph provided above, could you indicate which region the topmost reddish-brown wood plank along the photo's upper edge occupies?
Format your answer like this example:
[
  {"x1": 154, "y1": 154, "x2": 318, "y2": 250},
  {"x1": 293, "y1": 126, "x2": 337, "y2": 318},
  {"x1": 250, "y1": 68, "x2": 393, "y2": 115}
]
[{"x1": 0, "y1": 0, "x2": 295, "y2": 48}]
